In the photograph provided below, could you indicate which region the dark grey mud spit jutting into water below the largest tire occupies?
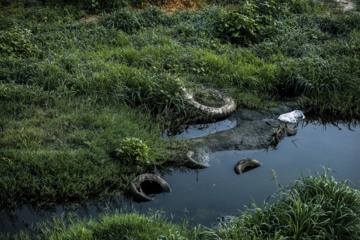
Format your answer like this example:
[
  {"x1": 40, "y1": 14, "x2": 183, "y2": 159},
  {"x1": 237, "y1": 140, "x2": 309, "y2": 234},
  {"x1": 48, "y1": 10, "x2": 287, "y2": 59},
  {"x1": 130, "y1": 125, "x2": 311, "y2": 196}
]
[{"x1": 187, "y1": 102, "x2": 304, "y2": 168}]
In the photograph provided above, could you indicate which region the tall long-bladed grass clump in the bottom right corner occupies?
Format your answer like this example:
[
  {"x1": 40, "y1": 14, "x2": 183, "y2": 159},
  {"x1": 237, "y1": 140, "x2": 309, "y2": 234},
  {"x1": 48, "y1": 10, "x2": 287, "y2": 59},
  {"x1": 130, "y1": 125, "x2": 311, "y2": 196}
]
[{"x1": 214, "y1": 170, "x2": 360, "y2": 239}]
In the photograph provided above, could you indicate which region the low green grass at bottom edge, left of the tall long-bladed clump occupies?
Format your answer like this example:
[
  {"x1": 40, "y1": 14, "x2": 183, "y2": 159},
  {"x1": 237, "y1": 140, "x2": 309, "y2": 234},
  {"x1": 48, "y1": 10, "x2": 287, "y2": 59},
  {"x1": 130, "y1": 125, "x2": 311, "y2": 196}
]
[{"x1": 24, "y1": 210, "x2": 206, "y2": 240}]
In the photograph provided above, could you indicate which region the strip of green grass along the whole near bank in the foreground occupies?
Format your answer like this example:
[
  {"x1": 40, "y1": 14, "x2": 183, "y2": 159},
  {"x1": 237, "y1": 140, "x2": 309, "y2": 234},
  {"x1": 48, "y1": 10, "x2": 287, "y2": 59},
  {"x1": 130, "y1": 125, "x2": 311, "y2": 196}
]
[{"x1": 4, "y1": 172, "x2": 360, "y2": 240}]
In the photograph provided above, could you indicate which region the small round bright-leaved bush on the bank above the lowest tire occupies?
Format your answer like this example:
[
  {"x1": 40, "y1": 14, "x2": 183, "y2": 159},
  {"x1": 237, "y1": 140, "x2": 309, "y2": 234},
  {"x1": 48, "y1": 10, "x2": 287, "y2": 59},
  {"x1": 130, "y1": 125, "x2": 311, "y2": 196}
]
[{"x1": 116, "y1": 138, "x2": 151, "y2": 165}]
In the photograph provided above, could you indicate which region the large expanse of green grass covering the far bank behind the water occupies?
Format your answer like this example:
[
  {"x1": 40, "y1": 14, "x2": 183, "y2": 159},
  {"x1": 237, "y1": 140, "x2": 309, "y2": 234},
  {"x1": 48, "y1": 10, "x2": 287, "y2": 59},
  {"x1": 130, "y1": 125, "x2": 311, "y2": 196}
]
[{"x1": 0, "y1": 0, "x2": 360, "y2": 220}]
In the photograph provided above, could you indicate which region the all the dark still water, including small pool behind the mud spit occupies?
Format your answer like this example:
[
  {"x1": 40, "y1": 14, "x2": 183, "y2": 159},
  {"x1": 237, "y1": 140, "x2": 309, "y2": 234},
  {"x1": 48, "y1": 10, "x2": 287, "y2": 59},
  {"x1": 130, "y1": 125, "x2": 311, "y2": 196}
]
[{"x1": 0, "y1": 120, "x2": 360, "y2": 233}]
